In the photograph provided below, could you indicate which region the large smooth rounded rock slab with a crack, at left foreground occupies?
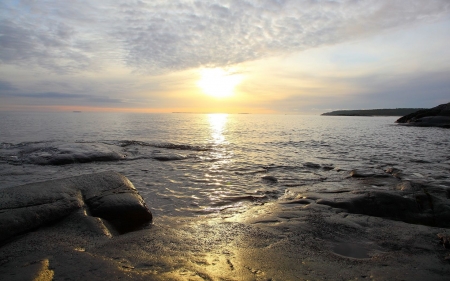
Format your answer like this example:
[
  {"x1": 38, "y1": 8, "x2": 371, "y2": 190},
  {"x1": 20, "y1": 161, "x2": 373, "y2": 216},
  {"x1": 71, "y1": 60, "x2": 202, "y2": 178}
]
[{"x1": 0, "y1": 172, "x2": 152, "y2": 243}]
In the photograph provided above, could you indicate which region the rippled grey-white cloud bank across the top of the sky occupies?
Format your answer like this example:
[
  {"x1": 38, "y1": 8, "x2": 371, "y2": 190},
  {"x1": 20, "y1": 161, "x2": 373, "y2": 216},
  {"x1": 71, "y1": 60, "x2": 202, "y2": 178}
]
[{"x1": 0, "y1": 0, "x2": 450, "y2": 73}]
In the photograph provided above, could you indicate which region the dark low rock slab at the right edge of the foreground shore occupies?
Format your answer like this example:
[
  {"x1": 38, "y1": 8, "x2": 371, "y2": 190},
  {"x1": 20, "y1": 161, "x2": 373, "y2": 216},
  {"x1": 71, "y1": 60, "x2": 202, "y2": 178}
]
[{"x1": 283, "y1": 174, "x2": 450, "y2": 228}]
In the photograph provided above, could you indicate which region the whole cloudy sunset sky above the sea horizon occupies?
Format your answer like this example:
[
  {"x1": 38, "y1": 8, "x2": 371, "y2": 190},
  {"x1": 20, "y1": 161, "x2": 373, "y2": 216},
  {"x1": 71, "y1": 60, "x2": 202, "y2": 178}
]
[{"x1": 0, "y1": 0, "x2": 450, "y2": 114}]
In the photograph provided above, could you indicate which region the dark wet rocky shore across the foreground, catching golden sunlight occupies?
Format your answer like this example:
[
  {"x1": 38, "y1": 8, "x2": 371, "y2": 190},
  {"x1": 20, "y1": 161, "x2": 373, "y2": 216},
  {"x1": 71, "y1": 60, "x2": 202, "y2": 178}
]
[{"x1": 0, "y1": 171, "x2": 450, "y2": 280}]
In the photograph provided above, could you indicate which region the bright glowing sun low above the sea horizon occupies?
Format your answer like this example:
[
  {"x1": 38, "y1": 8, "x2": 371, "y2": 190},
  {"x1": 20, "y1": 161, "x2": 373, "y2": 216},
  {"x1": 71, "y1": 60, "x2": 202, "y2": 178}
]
[{"x1": 197, "y1": 68, "x2": 242, "y2": 98}]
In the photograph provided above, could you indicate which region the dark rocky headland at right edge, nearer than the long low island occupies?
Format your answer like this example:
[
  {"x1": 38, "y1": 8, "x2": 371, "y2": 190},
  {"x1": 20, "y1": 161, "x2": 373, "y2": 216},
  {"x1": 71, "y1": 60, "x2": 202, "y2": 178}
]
[{"x1": 395, "y1": 102, "x2": 450, "y2": 128}]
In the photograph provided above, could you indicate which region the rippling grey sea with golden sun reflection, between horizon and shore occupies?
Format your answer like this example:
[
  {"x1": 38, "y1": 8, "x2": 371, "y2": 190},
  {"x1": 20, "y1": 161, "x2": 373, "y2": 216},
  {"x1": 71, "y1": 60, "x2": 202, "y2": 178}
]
[{"x1": 0, "y1": 112, "x2": 450, "y2": 216}]
